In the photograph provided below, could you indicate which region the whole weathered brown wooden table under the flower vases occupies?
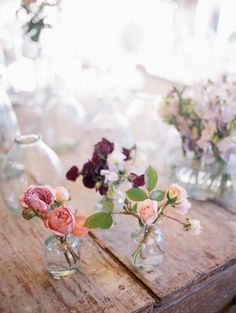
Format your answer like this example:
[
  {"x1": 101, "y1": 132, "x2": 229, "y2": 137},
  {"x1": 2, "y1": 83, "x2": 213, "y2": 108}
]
[{"x1": 0, "y1": 143, "x2": 236, "y2": 313}]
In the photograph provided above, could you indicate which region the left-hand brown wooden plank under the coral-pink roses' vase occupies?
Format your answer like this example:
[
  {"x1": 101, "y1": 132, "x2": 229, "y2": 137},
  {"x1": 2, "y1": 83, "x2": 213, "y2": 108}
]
[{"x1": 0, "y1": 197, "x2": 154, "y2": 313}]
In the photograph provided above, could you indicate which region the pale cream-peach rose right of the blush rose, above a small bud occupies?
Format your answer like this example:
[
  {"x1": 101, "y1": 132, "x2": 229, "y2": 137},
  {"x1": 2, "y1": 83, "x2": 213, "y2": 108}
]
[{"x1": 167, "y1": 184, "x2": 191, "y2": 215}]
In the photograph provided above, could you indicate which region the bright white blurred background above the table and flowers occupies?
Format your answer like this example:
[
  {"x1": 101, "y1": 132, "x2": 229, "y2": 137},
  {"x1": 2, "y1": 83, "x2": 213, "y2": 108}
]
[{"x1": 0, "y1": 0, "x2": 236, "y2": 158}]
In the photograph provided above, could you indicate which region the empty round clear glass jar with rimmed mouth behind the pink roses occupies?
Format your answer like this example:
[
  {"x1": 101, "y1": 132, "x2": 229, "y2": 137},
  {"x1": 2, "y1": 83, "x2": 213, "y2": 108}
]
[{"x1": 0, "y1": 134, "x2": 64, "y2": 213}]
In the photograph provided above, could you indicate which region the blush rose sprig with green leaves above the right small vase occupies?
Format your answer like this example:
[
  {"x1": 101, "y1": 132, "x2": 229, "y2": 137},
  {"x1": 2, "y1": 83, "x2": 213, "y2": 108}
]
[{"x1": 81, "y1": 166, "x2": 201, "y2": 235}]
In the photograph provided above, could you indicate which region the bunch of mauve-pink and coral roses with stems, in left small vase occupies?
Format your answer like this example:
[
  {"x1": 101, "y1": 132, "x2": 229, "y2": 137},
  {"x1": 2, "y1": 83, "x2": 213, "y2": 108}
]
[{"x1": 20, "y1": 185, "x2": 88, "y2": 266}]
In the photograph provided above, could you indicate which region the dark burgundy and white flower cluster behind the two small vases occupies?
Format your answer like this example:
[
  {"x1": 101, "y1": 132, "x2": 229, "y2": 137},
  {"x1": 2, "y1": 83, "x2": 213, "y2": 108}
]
[{"x1": 66, "y1": 138, "x2": 144, "y2": 198}]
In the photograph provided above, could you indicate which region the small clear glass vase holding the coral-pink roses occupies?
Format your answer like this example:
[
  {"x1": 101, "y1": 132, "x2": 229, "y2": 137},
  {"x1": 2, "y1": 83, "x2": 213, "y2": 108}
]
[{"x1": 44, "y1": 235, "x2": 81, "y2": 279}]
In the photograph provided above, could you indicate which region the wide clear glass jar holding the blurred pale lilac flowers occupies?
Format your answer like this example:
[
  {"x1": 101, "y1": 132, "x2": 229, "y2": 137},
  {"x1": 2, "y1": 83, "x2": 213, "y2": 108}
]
[{"x1": 169, "y1": 148, "x2": 236, "y2": 201}]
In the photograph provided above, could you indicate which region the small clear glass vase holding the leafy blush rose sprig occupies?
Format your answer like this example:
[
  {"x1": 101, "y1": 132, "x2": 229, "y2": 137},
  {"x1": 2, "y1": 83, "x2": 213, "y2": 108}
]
[{"x1": 130, "y1": 224, "x2": 164, "y2": 271}]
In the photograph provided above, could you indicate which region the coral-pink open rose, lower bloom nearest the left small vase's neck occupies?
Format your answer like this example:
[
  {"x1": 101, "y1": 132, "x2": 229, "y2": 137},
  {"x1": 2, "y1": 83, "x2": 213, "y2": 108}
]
[{"x1": 45, "y1": 205, "x2": 75, "y2": 236}]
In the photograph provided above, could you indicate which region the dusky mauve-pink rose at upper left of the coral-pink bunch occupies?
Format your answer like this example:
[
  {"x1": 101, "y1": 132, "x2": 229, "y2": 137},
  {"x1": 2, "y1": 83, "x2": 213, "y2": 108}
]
[{"x1": 20, "y1": 185, "x2": 56, "y2": 214}]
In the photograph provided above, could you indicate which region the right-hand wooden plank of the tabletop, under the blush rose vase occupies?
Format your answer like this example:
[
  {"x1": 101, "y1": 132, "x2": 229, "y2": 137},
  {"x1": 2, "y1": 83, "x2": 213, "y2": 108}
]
[{"x1": 65, "y1": 179, "x2": 236, "y2": 312}]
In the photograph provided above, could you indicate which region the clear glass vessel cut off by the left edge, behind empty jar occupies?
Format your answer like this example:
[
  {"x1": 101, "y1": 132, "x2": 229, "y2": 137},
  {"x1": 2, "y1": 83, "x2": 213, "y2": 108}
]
[{"x1": 0, "y1": 87, "x2": 20, "y2": 152}]
